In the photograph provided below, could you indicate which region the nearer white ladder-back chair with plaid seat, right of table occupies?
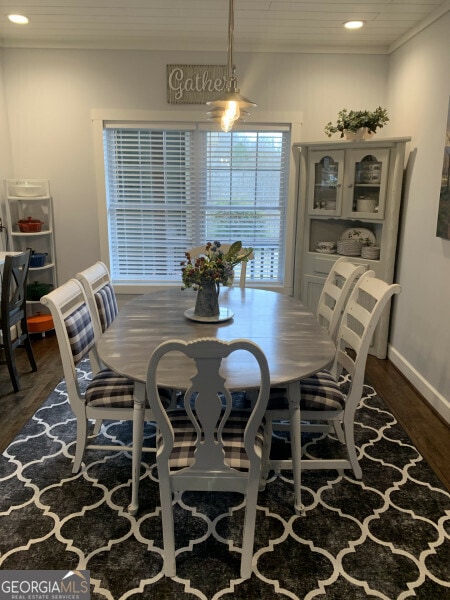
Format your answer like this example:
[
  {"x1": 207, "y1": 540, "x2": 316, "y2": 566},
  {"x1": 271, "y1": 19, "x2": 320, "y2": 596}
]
[{"x1": 264, "y1": 271, "x2": 401, "y2": 496}]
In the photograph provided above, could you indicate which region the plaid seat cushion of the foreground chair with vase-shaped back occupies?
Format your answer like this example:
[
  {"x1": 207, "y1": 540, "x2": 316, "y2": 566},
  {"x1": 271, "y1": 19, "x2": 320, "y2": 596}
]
[{"x1": 156, "y1": 409, "x2": 264, "y2": 471}]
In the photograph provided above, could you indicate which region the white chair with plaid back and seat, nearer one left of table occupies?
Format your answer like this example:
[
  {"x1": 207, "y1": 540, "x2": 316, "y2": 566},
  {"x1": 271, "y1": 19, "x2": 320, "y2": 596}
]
[{"x1": 41, "y1": 279, "x2": 170, "y2": 473}]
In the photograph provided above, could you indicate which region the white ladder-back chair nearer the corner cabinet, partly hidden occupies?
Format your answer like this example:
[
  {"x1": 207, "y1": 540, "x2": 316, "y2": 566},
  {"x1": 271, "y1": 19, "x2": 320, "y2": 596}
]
[{"x1": 316, "y1": 256, "x2": 366, "y2": 341}]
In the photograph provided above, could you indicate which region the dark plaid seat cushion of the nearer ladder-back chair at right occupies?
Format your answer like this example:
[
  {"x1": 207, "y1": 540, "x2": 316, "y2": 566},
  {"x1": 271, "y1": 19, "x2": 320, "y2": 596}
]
[{"x1": 267, "y1": 369, "x2": 345, "y2": 411}]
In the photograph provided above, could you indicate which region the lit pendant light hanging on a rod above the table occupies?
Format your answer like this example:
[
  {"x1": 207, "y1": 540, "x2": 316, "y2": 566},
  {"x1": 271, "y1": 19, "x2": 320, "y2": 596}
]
[{"x1": 206, "y1": 0, "x2": 256, "y2": 132}]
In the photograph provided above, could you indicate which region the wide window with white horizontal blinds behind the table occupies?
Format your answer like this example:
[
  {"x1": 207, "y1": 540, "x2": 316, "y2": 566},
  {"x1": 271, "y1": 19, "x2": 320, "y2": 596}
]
[{"x1": 103, "y1": 123, "x2": 290, "y2": 284}]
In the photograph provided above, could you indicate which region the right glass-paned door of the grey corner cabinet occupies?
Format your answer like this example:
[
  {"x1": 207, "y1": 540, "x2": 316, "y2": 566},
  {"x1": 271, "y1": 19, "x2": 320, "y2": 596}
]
[{"x1": 344, "y1": 148, "x2": 389, "y2": 219}]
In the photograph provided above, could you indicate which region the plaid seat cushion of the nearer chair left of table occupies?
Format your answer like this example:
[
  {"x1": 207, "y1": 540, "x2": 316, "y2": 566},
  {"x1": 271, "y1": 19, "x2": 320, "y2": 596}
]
[{"x1": 84, "y1": 369, "x2": 171, "y2": 408}]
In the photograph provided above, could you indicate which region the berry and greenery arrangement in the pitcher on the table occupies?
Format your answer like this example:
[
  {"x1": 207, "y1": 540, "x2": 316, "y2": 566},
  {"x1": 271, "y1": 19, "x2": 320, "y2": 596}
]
[{"x1": 181, "y1": 241, "x2": 253, "y2": 290}]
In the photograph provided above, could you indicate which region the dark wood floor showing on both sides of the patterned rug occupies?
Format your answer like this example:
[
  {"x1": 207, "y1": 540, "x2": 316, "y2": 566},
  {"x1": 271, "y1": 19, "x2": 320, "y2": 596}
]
[{"x1": 0, "y1": 332, "x2": 450, "y2": 491}]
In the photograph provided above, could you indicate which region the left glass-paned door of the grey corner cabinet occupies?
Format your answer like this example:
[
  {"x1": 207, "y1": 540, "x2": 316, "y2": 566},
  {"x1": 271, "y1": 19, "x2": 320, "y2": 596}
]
[{"x1": 308, "y1": 150, "x2": 344, "y2": 215}]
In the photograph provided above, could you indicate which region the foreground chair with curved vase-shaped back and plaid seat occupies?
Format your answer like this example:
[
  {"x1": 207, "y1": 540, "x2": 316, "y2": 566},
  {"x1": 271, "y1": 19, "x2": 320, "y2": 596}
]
[{"x1": 133, "y1": 339, "x2": 270, "y2": 578}]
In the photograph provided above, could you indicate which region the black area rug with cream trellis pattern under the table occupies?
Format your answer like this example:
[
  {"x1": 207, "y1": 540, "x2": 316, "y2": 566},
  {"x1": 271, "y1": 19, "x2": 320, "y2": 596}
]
[{"x1": 0, "y1": 362, "x2": 450, "y2": 600}]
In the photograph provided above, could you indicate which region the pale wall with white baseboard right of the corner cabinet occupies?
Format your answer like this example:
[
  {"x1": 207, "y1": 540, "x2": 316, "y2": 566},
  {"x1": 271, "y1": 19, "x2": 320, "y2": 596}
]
[{"x1": 387, "y1": 13, "x2": 450, "y2": 422}]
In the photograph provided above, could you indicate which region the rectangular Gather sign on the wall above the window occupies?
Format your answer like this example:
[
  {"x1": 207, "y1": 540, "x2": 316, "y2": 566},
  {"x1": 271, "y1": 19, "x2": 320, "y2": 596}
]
[{"x1": 167, "y1": 65, "x2": 227, "y2": 104}]
